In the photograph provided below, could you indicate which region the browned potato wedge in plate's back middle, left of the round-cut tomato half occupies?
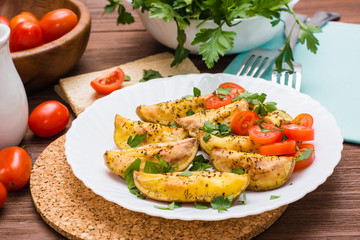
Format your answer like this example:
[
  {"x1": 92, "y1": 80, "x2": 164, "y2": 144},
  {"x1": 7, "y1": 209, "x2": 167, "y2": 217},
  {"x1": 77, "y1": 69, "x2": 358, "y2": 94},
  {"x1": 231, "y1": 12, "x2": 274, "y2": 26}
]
[{"x1": 175, "y1": 99, "x2": 249, "y2": 137}]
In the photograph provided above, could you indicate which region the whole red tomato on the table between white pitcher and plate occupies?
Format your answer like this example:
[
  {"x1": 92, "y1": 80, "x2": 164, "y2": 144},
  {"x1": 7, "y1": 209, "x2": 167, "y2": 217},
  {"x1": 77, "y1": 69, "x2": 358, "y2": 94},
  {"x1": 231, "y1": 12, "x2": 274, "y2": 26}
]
[{"x1": 29, "y1": 100, "x2": 69, "y2": 137}]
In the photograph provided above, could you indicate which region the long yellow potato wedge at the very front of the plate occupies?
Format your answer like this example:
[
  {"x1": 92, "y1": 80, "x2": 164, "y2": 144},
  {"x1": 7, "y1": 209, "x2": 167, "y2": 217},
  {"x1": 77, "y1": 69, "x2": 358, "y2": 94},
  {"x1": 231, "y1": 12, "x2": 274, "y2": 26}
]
[{"x1": 134, "y1": 171, "x2": 249, "y2": 202}]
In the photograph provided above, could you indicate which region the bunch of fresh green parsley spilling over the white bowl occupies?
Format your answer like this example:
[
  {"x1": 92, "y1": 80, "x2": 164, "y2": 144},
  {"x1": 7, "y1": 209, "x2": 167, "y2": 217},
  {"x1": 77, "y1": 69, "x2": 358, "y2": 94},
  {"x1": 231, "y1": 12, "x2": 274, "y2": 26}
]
[{"x1": 105, "y1": 0, "x2": 321, "y2": 71}]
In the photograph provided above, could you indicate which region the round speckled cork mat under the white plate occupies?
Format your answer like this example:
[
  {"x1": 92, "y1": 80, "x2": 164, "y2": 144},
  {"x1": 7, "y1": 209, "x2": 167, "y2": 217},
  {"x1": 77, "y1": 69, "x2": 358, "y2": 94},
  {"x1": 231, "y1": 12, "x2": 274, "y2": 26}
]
[{"x1": 30, "y1": 136, "x2": 287, "y2": 239}]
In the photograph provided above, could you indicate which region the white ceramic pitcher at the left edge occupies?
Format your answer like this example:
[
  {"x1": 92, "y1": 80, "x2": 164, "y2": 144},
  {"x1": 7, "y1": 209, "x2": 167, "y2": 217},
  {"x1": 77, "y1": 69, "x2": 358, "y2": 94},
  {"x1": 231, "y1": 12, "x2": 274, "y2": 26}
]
[{"x1": 0, "y1": 24, "x2": 29, "y2": 150}]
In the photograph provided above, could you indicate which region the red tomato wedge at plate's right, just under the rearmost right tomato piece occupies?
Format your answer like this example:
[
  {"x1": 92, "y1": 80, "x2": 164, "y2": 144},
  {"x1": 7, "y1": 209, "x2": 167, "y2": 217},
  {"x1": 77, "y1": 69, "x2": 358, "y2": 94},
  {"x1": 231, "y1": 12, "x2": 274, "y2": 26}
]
[{"x1": 281, "y1": 124, "x2": 314, "y2": 141}]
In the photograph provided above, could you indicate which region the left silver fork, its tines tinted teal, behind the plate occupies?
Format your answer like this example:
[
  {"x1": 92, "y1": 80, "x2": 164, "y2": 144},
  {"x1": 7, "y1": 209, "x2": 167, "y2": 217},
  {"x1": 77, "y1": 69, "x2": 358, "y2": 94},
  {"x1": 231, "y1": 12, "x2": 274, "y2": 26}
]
[{"x1": 236, "y1": 14, "x2": 306, "y2": 77}]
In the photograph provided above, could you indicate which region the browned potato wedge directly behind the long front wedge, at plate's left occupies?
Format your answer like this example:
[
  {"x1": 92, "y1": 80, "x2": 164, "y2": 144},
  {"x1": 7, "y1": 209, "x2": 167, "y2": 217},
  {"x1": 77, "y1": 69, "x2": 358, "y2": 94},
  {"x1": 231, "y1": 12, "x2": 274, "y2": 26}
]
[{"x1": 104, "y1": 138, "x2": 199, "y2": 177}]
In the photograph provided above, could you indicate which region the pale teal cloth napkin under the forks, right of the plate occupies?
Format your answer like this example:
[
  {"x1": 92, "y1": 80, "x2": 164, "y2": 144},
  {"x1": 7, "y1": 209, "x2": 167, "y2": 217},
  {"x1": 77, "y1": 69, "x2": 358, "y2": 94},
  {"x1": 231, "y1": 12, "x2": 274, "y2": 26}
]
[{"x1": 224, "y1": 22, "x2": 360, "y2": 144}]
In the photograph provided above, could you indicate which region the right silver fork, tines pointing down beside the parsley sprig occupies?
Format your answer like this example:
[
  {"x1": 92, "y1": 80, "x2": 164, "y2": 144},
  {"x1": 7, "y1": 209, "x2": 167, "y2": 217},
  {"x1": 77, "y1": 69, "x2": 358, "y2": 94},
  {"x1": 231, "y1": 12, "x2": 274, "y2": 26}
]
[{"x1": 271, "y1": 11, "x2": 340, "y2": 92}]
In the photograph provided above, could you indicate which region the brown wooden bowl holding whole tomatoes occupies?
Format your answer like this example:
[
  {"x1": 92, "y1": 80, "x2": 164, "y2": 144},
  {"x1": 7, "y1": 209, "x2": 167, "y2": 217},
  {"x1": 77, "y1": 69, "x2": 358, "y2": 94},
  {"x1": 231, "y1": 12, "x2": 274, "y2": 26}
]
[{"x1": 0, "y1": 0, "x2": 91, "y2": 92}]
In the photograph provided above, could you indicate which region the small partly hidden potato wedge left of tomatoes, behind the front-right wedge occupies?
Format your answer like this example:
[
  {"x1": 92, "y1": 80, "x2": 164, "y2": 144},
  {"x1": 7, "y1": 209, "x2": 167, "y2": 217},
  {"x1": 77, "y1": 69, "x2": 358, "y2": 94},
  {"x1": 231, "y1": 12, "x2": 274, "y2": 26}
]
[{"x1": 199, "y1": 130, "x2": 260, "y2": 154}]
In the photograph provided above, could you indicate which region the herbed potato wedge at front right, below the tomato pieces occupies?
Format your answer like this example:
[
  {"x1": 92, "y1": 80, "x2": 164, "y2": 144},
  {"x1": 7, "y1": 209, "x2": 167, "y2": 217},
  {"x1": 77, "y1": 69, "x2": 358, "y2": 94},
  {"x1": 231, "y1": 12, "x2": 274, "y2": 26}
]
[{"x1": 210, "y1": 147, "x2": 295, "y2": 191}]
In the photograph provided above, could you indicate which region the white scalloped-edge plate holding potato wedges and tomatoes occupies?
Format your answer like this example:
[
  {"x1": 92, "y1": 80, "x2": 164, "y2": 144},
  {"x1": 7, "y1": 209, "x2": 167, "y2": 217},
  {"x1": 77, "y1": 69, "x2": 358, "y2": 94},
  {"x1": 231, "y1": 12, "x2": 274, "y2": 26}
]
[{"x1": 65, "y1": 74, "x2": 343, "y2": 221}]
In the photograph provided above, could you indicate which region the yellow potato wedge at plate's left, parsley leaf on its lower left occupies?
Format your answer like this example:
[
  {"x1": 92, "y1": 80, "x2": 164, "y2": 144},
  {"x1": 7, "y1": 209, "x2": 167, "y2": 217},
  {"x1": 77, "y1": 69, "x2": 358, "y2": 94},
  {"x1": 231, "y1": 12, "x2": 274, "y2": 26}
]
[{"x1": 114, "y1": 114, "x2": 188, "y2": 149}]
